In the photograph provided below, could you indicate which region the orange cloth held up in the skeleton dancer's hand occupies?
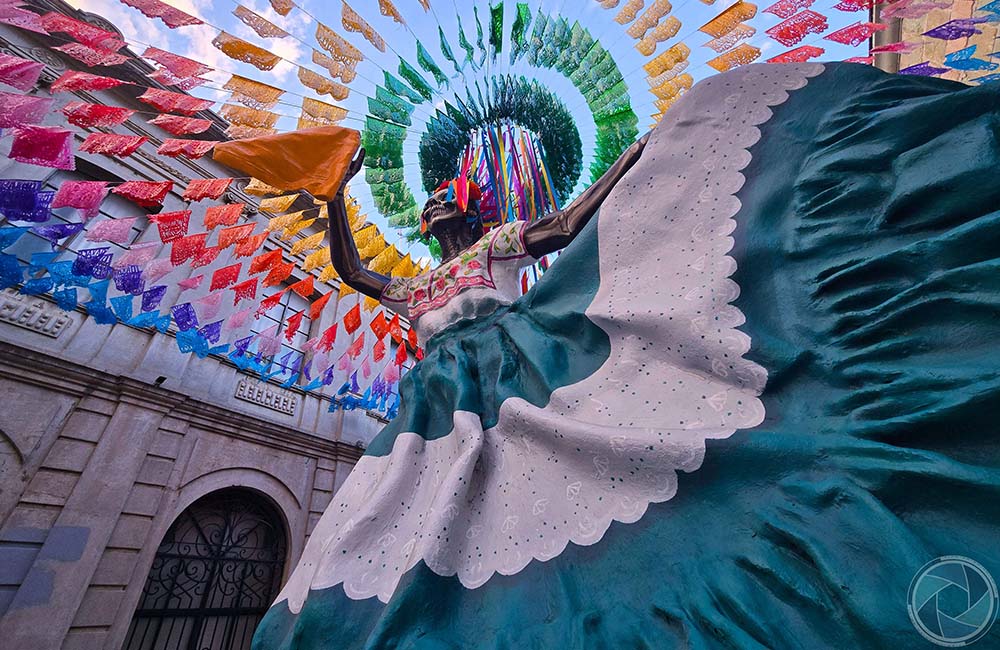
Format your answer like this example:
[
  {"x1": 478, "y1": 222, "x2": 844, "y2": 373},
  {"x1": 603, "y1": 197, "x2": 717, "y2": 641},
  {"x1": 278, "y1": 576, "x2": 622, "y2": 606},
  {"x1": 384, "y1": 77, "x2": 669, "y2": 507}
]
[{"x1": 212, "y1": 126, "x2": 361, "y2": 201}]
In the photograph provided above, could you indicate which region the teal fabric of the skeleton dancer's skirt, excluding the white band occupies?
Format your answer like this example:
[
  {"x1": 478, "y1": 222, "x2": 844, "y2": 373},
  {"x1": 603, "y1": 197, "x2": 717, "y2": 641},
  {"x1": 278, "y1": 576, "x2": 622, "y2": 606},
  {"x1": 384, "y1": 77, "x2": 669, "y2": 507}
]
[{"x1": 254, "y1": 64, "x2": 1000, "y2": 650}]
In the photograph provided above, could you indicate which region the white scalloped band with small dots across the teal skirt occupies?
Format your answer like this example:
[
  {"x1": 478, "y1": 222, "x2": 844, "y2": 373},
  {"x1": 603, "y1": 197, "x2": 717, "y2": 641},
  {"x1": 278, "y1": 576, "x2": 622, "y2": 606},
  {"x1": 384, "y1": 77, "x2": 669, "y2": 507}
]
[{"x1": 278, "y1": 64, "x2": 823, "y2": 612}]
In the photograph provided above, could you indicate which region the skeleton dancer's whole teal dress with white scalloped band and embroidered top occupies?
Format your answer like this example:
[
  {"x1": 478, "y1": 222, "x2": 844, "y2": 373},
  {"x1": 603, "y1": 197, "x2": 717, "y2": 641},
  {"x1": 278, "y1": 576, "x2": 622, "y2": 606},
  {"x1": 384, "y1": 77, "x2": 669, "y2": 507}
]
[{"x1": 255, "y1": 64, "x2": 1000, "y2": 650}]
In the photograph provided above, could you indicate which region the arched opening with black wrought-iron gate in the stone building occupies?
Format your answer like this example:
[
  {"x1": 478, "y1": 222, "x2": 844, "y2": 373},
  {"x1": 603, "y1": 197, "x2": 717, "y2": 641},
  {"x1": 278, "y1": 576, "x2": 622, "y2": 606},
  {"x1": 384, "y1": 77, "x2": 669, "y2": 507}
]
[{"x1": 123, "y1": 489, "x2": 286, "y2": 650}]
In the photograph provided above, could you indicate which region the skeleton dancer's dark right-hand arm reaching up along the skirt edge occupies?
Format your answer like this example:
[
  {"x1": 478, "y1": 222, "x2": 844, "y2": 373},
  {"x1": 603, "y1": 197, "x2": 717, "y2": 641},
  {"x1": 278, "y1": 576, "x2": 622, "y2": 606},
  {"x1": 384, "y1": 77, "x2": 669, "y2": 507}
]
[{"x1": 524, "y1": 133, "x2": 650, "y2": 258}]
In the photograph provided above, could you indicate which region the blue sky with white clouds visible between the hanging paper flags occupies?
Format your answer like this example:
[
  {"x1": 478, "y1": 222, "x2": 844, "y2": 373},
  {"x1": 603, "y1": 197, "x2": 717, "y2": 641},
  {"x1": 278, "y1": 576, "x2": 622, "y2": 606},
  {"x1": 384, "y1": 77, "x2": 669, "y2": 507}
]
[{"x1": 67, "y1": 0, "x2": 867, "y2": 257}]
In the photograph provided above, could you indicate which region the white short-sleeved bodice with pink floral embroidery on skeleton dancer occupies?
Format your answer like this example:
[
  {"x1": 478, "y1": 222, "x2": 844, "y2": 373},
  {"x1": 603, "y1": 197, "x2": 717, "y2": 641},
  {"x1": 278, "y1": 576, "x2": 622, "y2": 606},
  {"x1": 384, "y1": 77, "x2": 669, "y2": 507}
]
[{"x1": 382, "y1": 221, "x2": 535, "y2": 341}]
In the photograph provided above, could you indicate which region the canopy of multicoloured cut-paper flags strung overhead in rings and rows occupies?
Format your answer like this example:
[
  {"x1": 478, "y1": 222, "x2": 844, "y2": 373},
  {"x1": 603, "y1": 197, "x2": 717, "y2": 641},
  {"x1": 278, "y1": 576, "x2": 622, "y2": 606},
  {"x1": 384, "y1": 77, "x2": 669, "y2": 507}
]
[{"x1": 0, "y1": 0, "x2": 1000, "y2": 417}]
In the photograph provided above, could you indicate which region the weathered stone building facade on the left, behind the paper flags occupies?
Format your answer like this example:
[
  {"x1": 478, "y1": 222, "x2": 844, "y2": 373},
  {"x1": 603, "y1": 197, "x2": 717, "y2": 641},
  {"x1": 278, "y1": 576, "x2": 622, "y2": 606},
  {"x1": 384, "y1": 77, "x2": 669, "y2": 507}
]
[{"x1": 0, "y1": 0, "x2": 410, "y2": 650}]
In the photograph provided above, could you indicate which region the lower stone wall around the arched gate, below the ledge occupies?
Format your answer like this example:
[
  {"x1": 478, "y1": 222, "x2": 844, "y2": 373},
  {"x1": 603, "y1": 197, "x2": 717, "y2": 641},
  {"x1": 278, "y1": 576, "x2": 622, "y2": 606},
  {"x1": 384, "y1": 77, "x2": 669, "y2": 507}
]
[{"x1": 0, "y1": 343, "x2": 361, "y2": 650}]
